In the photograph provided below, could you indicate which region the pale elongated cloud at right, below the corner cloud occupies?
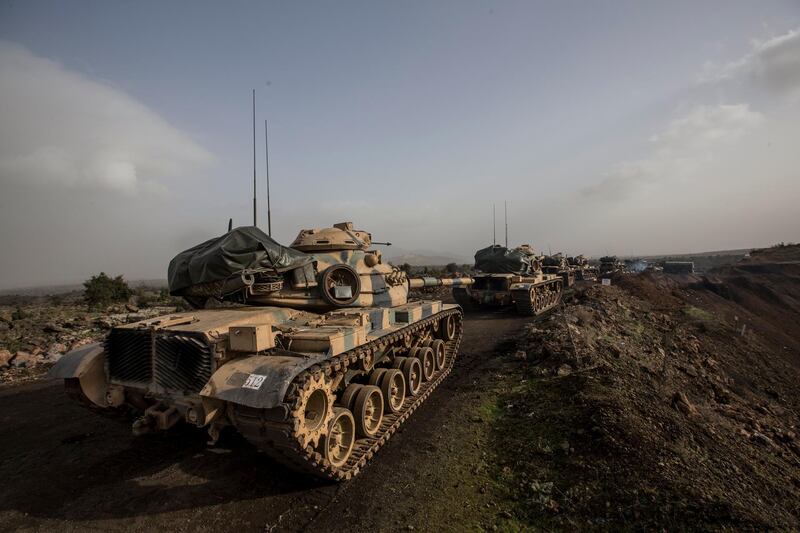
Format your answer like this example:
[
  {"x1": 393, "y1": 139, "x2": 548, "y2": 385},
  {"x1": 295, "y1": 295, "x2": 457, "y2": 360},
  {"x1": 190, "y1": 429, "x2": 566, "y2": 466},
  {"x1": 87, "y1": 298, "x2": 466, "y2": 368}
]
[{"x1": 580, "y1": 104, "x2": 764, "y2": 201}]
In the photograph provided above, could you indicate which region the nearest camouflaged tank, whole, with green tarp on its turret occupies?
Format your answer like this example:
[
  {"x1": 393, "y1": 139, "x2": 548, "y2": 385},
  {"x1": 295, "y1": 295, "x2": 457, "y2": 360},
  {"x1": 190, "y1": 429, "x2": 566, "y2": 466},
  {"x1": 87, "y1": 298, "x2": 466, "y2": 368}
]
[{"x1": 50, "y1": 222, "x2": 472, "y2": 481}]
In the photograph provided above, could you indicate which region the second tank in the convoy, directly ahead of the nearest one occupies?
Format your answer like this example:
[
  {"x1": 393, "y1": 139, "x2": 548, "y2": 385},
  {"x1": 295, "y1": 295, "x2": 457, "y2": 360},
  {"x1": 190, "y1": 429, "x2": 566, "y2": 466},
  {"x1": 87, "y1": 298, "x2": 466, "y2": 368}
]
[{"x1": 453, "y1": 244, "x2": 563, "y2": 316}]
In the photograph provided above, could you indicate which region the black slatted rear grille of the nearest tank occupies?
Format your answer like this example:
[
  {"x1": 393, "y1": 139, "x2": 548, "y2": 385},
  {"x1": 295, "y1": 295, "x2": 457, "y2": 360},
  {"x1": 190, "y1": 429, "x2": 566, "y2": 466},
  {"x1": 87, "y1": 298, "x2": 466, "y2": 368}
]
[{"x1": 105, "y1": 328, "x2": 214, "y2": 392}]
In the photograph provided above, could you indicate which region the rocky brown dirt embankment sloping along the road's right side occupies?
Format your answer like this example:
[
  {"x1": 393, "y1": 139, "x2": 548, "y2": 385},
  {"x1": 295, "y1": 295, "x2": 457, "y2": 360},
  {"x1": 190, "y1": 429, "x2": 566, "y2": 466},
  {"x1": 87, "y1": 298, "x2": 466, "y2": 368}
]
[{"x1": 482, "y1": 258, "x2": 800, "y2": 529}]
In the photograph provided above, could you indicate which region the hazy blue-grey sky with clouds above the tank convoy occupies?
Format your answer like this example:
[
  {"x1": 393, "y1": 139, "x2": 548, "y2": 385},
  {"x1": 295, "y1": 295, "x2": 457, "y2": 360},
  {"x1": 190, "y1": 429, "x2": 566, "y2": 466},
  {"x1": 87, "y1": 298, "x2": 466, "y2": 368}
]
[{"x1": 0, "y1": 0, "x2": 800, "y2": 289}]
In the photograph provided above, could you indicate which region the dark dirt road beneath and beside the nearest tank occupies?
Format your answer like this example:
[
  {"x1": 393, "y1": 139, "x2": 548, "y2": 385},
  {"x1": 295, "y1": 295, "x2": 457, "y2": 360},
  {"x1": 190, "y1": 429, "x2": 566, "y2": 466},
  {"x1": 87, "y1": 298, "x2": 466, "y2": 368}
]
[{"x1": 0, "y1": 312, "x2": 527, "y2": 531}]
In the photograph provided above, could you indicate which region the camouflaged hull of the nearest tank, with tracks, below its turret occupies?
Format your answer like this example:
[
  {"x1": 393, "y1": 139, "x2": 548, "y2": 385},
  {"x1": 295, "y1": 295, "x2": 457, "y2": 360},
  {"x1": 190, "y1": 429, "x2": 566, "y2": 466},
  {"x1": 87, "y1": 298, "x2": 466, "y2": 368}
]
[{"x1": 51, "y1": 301, "x2": 462, "y2": 480}]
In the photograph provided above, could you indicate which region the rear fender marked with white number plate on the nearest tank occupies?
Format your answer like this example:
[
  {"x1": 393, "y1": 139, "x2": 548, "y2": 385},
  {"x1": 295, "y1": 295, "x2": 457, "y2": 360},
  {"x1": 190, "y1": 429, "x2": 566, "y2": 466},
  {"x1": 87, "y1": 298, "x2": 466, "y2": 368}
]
[{"x1": 200, "y1": 352, "x2": 328, "y2": 409}]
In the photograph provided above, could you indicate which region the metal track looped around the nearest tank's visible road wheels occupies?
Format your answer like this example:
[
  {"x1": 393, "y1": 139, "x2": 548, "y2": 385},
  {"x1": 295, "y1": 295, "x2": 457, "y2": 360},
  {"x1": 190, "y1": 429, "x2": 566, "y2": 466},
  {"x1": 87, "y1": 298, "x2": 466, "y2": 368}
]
[{"x1": 228, "y1": 309, "x2": 463, "y2": 481}]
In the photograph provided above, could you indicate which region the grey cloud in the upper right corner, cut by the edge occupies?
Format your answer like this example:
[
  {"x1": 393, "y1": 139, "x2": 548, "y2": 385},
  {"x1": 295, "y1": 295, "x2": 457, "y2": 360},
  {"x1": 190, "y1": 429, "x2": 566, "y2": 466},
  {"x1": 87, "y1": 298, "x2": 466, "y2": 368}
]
[{"x1": 700, "y1": 29, "x2": 800, "y2": 101}]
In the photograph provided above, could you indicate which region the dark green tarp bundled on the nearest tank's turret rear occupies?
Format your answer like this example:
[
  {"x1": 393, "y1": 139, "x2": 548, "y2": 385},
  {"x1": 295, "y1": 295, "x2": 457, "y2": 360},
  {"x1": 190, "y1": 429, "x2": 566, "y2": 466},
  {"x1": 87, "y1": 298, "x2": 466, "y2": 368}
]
[{"x1": 167, "y1": 222, "x2": 313, "y2": 295}]
